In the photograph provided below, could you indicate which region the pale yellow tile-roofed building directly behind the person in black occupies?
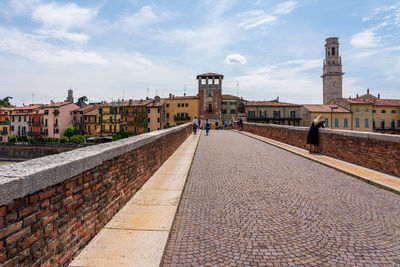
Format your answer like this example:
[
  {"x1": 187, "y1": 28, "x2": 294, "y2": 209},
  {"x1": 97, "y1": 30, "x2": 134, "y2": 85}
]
[{"x1": 301, "y1": 105, "x2": 352, "y2": 130}]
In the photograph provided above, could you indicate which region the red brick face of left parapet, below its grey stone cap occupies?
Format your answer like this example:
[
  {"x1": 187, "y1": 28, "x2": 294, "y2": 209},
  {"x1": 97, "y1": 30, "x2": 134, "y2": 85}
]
[{"x1": 0, "y1": 126, "x2": 191, "y2": 266}]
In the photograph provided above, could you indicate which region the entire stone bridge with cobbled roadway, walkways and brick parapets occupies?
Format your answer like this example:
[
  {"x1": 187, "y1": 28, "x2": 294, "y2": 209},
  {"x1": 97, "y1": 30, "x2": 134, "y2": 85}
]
[{"x1": 0, "y1": 123, "x2": 400, "y2": 266}]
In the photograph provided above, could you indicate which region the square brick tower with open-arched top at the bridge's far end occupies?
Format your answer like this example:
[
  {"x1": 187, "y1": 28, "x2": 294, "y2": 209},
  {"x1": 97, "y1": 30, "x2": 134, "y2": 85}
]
[{"x1": 197, "y1": 73, "x2": 224, "y2": 123}]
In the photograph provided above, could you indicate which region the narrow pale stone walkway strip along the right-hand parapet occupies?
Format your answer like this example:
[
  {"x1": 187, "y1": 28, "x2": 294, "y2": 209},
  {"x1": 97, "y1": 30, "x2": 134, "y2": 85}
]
[{"x1": 236, "y1": 131, "x2": 400, "y2": 194}]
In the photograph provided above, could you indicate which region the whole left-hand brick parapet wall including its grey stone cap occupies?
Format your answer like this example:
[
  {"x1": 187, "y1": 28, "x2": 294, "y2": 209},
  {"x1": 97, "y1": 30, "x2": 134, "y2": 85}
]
[{"x1": 0, "y1": 124, "x2": 192, "y2": 266}]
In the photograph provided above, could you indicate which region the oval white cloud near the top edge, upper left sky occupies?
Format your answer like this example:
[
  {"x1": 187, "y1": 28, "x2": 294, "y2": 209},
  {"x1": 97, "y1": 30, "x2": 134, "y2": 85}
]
[{"x1": 32, "y1": 2, "x2": 97, "y2": 30}]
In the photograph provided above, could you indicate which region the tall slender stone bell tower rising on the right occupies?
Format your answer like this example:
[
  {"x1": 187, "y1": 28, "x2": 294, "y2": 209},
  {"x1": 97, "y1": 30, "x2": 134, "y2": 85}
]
[{"x1": 321, "y1": 37, "x2": 344, "y2": 105}]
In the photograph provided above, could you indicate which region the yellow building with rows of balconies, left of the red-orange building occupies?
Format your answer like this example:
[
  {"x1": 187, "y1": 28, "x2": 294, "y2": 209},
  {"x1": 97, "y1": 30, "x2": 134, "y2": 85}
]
[{"x1": 96, "y1": 102, "x2": 122, "y2": 136}]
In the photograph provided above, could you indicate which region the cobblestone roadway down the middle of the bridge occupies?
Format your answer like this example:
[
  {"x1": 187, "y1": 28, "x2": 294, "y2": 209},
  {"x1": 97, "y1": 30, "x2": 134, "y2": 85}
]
[{"x1": 163, "y1": 131, "x2": 400, "y2": 266}]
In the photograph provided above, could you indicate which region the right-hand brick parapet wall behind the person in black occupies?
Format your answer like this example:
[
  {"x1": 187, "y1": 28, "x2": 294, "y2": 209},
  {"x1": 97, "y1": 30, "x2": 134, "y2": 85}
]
[{"x1": 235, "y1": 123, "x2": 400, "y2": 177}]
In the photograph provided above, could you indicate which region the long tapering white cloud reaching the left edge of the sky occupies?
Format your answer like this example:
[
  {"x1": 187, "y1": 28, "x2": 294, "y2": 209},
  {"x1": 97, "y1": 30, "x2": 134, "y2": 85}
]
[{"x1": 0, "y1": 27, "x2": 106, "y2": 64}]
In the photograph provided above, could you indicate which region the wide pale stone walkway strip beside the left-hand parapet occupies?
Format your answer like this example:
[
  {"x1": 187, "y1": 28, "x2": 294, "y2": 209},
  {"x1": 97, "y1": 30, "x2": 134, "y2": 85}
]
[{"x1": 69, "y1": 135, "x2": 199, "y2": 267}]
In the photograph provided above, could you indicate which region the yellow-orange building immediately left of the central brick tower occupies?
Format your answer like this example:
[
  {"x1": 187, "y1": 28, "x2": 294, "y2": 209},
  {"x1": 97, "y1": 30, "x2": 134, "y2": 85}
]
[{"x1": 164, "y1": 94, "x2": 199, "y2": 127}]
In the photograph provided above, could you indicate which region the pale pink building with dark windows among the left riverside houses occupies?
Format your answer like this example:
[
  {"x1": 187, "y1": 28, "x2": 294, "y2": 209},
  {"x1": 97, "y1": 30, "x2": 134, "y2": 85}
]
[{"x1": 43, "y1": 101, "x2": 79, "y2": 139}]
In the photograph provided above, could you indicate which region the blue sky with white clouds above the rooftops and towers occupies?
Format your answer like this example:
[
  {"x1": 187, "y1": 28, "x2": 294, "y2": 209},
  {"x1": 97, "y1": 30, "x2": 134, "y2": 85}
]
[{"x1": 0, "y1": 0, "x2": 400, "y2": 105}]
